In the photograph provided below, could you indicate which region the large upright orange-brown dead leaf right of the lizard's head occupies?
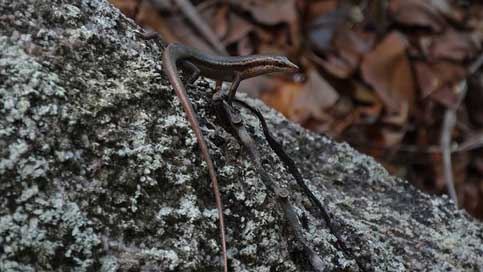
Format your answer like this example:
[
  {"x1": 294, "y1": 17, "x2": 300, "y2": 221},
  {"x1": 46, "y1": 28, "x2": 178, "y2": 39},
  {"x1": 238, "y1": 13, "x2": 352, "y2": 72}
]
[{"x1": 361, "y1": 32, "x2": 414, "y2": 112}]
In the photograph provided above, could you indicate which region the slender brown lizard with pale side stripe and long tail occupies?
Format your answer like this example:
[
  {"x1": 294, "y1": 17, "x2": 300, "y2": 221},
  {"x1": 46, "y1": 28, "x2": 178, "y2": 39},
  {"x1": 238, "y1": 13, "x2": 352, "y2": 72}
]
[{"x1": 162, "y1": 43, "x2": 298, "y2": 272}]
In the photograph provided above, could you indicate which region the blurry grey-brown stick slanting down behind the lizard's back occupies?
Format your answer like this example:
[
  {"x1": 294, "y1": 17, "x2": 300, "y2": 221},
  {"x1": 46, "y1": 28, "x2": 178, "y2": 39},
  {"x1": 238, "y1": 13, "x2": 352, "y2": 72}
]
[{"x1": 173, "y1": 0, "x2": 228, "y2": 56}]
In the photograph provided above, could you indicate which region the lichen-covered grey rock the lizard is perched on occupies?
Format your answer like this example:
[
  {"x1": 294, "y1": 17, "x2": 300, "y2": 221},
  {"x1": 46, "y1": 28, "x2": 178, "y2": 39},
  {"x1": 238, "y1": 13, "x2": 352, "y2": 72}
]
[{"x1": 0, "y1": 0, "x2": 483, "y2": 272}]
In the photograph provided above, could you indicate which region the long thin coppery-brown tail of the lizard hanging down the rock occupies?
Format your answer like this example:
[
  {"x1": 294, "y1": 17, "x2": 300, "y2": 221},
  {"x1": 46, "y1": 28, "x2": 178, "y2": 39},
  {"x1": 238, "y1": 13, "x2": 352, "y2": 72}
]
[{"x1": 163, "y1": 44, "x2": 228, "y2": 272}]
